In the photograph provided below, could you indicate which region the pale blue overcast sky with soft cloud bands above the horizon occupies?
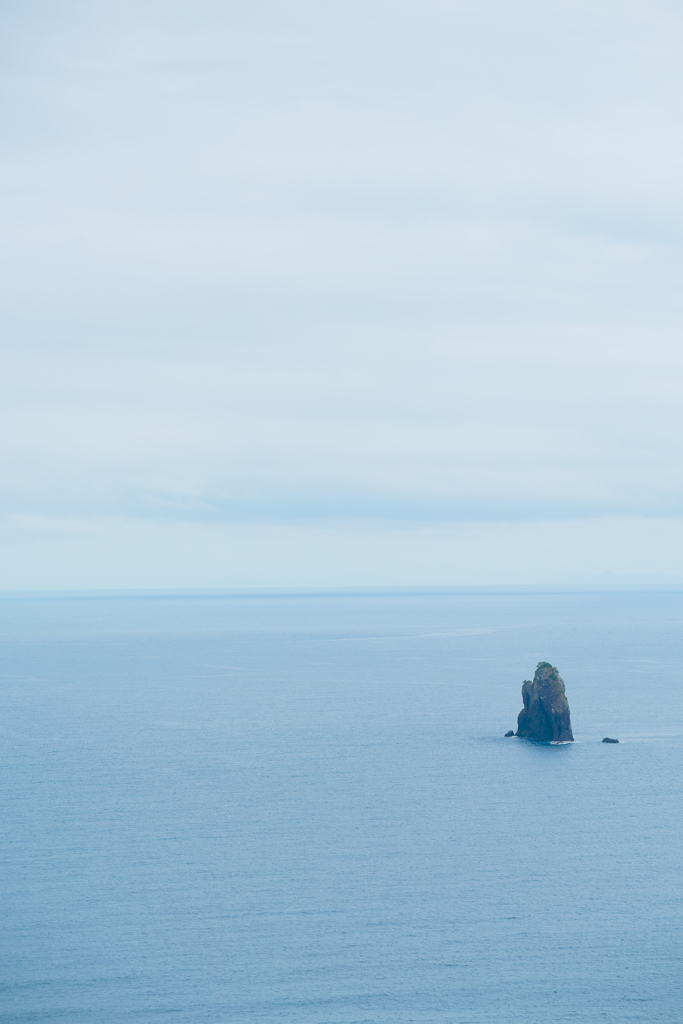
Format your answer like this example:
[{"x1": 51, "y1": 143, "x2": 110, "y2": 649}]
[{"x1": 0, "y1": 0, "x2": 683, "y2": 590}]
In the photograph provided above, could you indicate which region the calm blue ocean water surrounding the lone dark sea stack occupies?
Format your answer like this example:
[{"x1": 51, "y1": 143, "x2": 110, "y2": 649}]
[{"x1": 0, "y1": 590, "x2": 683, "y2": 1024}]
